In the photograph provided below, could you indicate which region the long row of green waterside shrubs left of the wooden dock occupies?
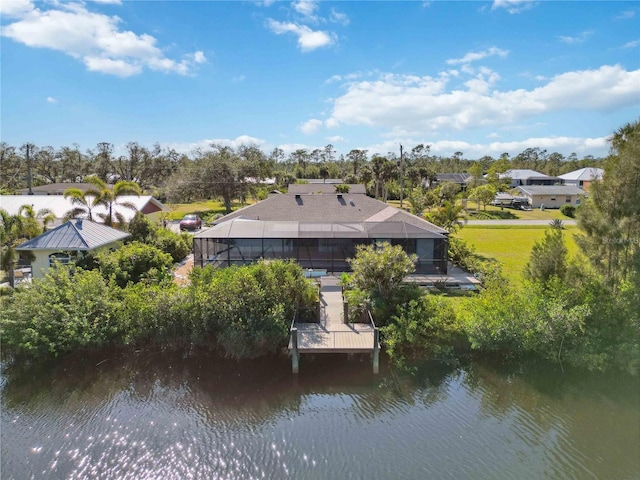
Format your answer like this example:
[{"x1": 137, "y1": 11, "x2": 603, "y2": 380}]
[{"x1": 2, "y1": 258, "x2": 317, "y2": 358}]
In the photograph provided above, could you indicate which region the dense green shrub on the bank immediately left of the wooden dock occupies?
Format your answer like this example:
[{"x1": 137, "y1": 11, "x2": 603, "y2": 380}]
[{"x1": 184, "y1": 260, "x2": 317, "y2": 358}]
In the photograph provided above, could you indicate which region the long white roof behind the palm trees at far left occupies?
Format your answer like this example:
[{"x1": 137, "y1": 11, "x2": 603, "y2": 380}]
[{"x1": 0, "y1": 195, "x2": 169, "y2": 226}]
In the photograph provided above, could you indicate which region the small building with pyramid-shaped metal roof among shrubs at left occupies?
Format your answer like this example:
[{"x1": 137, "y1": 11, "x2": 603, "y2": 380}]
[{"x1": 16, "y1": 218, "x2": 130, "y2": 278}]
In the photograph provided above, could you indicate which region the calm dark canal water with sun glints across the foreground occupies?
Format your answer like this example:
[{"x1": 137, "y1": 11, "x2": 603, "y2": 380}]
[{"x1": 0, "y1": 352, "x2": 640, "y2": 480}]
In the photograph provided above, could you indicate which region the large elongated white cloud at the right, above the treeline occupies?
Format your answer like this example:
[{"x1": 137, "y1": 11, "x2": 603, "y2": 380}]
[{"x1": 325, "y1": 65, "x2": 640, "y2": 133}]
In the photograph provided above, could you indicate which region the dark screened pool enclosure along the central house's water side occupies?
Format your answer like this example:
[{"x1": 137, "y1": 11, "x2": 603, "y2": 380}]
[{"x1": 193, "y1": 218, "x2": 447, "y2": 274}]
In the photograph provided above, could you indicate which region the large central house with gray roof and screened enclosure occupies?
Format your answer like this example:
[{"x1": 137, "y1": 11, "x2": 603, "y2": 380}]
[{"x1": 194, "y1": 194, "x2": 448, "y2": 274}]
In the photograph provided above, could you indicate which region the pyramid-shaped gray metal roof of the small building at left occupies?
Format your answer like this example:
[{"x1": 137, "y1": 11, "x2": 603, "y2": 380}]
[{"x1": 16, "y1": 219, "x2": 129, "y2": 251}]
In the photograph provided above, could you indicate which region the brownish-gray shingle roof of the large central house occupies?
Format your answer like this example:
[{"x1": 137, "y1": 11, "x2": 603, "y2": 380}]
[{"x1": 216, "y1": 194, "x2": 447, "y2": 234}]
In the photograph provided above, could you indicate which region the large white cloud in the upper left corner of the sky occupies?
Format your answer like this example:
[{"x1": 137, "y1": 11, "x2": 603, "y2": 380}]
[{"x1": 2, "y1": 1, "x2": 206, "y2": 77}]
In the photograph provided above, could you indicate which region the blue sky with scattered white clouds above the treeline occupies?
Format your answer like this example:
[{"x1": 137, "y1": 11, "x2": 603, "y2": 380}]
[{"x1": 0, "y1": 0, "x2": 640, "y2": 158}]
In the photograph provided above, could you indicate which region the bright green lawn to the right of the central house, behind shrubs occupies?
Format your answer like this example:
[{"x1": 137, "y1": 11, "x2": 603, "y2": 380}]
[{"x1": 456, "y1": 225, "x2": 579, "y2": 281}]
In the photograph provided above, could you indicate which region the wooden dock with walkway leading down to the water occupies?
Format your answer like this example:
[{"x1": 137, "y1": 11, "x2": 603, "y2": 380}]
[{"x1": 289, "y1": 276, "x2": 380, "y2": 373}]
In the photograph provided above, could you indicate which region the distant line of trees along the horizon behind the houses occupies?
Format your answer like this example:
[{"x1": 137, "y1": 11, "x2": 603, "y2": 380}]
[{"x1": 0, "y1": 142, "x2": 605, "y2": 210}]
